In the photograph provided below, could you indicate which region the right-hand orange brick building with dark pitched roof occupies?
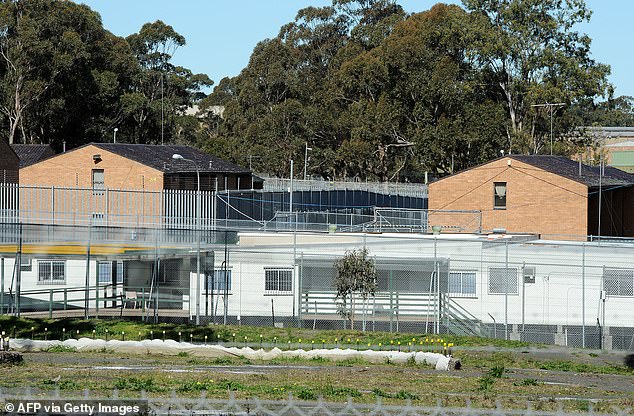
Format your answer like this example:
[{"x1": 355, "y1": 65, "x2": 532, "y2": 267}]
[{"x1": 429, "y1": 155, "x2": 634, "y2": 239}]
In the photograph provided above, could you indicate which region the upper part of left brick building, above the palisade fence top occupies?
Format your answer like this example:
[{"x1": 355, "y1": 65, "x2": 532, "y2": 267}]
[{"x1": 20, "y1": 143, "x2": 253, "y2": 191}]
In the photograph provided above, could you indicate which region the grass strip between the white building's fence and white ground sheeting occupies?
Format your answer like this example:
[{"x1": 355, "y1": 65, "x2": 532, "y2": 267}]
[{"x1": 0, "y1": 316, "x2": 529, "y2": 352}]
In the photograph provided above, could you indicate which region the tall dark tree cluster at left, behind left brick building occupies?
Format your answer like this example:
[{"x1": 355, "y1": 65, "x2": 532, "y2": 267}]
[{"x1": 0, "y1": 0, "x2": 212, "y2": 149}]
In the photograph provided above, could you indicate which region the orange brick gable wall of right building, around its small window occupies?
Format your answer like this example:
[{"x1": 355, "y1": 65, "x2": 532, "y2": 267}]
[{"x1": 429, "y1": 158, "x2": 588, "y2": 238}]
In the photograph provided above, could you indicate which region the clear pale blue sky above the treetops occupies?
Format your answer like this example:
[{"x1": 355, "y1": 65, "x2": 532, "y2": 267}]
[{"x1": 75, "y1": 0, "x2": 634, "y2": 96}]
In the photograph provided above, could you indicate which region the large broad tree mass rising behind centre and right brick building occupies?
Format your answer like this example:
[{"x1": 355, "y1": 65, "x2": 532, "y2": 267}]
[{"x1": 201, "y1": 0, "x2": 623, "y2": 181}]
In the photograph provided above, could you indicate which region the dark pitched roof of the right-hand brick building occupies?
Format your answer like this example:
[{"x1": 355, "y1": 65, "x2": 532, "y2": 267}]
[{"x1": 507, "y1": 155, "x2": 634, "y2": 188}]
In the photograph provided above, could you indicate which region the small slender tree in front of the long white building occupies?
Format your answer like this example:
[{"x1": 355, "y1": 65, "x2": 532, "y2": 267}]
[{"x1": 335, "y1": 247, "x2": 377, "y2": 330}]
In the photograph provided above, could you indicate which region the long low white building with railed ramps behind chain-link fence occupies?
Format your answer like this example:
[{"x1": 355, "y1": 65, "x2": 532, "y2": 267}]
[{"x1": 0, "y1": 223, "x2": 634, "y2": 350}]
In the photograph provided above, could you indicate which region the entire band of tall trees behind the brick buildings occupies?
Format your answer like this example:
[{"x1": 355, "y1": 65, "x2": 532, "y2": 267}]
[{"x1": 0, "y1": 0, "x2": 634, "y2": 177}]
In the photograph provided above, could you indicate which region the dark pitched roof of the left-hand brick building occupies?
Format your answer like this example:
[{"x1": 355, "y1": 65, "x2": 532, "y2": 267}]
[{"x1": 90, "y1": 143, "x2": 251, "y2": 173}]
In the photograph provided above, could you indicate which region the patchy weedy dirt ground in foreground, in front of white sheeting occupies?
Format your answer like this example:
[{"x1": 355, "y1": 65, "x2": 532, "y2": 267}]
[{"x1": 0, "y1": 347, "x2": 634, "y2": 410}]
